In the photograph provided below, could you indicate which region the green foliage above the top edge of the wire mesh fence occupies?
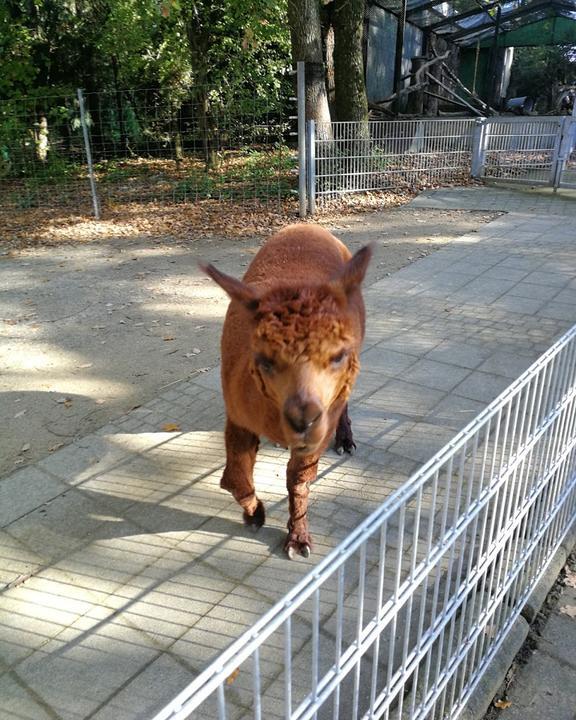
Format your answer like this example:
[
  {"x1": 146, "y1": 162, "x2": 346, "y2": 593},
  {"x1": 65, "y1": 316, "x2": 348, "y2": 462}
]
[{"x1": 0, "y1": 0, "x2": 290, "y2": 103}]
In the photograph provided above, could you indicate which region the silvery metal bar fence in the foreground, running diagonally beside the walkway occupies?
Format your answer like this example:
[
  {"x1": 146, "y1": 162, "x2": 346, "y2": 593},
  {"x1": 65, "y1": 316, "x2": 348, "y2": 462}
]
[{"x1": 155, "y1": 326, "x2": 576, "y2": 720}]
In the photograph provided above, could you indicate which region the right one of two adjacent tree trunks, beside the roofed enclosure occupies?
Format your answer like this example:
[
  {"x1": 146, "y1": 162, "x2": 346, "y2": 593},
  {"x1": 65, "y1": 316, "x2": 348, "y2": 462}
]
[{"x1": 332, "y1": 0, "x2": 368, "y2": 122}]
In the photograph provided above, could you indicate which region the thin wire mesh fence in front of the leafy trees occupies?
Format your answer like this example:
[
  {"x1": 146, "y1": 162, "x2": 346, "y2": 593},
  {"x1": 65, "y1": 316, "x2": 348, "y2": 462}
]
[{"x1": 0, "y1": 85, "x2": 297, "y2": 211}]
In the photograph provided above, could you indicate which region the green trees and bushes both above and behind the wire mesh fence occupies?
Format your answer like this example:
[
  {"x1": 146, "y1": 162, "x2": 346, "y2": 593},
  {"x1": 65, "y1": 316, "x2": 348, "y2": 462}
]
[{"x1": 0, "y1": 0, "x2": 291, "y2": 204}]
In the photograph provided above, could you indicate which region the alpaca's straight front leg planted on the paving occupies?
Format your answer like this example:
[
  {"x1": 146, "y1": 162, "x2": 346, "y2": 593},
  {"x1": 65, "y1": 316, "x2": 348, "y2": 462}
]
[{"x1": 284, "y1": 454, "x2": 320, "y2": 560}]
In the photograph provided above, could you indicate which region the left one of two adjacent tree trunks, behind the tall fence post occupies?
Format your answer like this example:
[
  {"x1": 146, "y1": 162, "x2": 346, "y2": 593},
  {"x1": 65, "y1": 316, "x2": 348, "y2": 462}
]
[{"x1": 288, "y1": 0, "x2": 331, "y2": 139}]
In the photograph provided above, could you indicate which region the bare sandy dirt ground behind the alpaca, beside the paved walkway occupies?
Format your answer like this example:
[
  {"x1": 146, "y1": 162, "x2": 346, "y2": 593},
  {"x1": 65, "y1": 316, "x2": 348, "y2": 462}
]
[{"x1": 0, "y1": 205, "x2": 494, "y2": 477}]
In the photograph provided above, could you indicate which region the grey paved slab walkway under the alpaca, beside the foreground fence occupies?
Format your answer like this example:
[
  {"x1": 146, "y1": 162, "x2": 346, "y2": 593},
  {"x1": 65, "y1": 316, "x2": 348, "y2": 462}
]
[{"x1": 0, "y1": 183, "x2": 576, "y2": 720}]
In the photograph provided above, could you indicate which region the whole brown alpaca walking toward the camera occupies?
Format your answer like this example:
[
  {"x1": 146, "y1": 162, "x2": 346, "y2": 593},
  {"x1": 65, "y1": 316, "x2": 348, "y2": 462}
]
[{"x1": 202, "y1": 225, "x2": 371, "y2": 559}]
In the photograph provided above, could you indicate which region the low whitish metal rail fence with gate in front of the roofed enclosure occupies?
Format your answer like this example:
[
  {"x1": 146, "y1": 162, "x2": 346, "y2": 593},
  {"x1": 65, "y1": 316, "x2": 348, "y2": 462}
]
[{"x1": 307, "y1": 117, "x2": 576, "y2": 207}]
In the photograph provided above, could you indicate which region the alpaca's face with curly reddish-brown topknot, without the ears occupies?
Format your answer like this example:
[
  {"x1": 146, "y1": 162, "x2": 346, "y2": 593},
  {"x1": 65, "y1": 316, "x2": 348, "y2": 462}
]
[{"x1": 253, "y1": 288, "x2": 360, "y2": 454}]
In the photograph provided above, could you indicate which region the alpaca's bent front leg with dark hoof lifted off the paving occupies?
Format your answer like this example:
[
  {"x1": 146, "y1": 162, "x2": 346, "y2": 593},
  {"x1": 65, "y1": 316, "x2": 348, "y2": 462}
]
[{"x1": 220, "y1": 419, "x2": 266, "y2": 528}]
